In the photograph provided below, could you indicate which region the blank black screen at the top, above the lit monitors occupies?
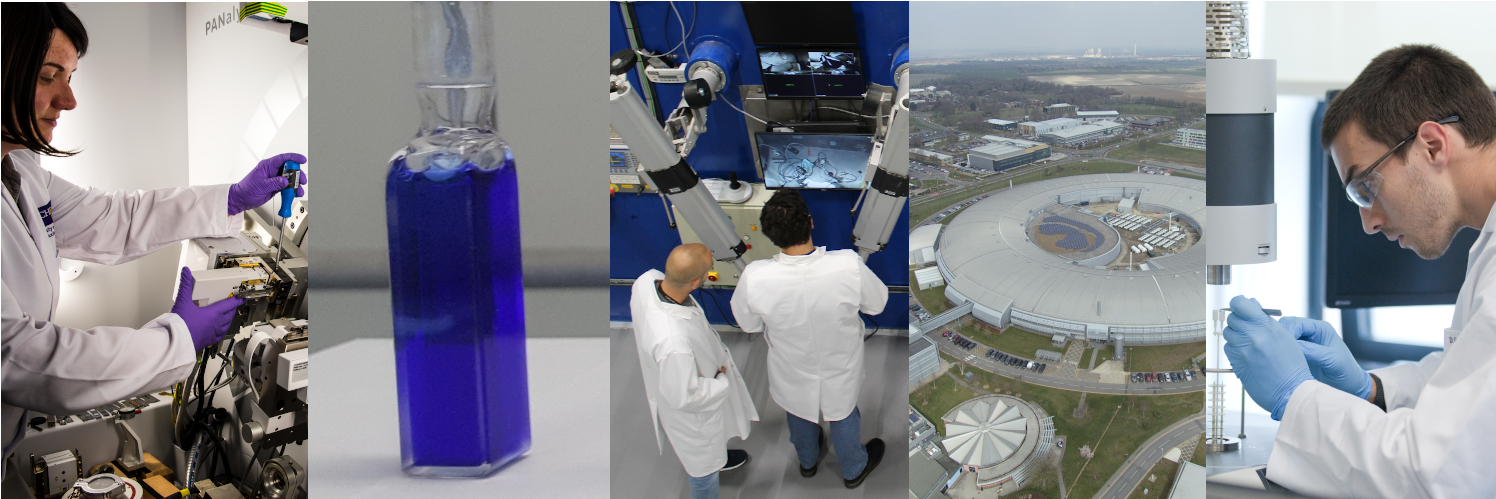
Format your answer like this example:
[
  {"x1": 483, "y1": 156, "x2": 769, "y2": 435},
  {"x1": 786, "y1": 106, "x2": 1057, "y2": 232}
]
[{"x1": 742, "y1": 1, "x2": 857, "y2": 46}]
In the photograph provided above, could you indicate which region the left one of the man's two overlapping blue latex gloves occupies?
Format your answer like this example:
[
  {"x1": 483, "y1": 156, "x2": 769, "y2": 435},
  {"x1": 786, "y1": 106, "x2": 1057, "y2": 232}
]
[{"x1": 1222, "y1": 296, "x2": 1313, "y2": 421}]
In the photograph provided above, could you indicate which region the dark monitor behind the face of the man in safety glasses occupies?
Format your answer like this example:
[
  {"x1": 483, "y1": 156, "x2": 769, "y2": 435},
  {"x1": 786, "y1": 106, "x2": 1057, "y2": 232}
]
[{"x1": 1310, "y1": 91, "x2": 1480, "y2": 308}]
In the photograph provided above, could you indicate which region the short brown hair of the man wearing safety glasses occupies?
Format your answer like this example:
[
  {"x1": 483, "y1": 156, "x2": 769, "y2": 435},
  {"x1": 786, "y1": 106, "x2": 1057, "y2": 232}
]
[{"x1": 1319, "y1": 45, "x2": 1496, "y2": 157}]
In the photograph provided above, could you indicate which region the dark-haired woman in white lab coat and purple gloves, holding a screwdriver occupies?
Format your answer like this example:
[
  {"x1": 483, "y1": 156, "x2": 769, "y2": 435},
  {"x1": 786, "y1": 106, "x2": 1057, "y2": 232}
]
[{"x1": 0, "y1": 1, "x2": 307, "y2": 459}]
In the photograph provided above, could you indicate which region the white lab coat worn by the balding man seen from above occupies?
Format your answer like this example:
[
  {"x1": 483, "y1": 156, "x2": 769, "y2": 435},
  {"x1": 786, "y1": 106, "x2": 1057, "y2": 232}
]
[{"x1": 628, "y1": 270, "x2": 758, "y2": 478}]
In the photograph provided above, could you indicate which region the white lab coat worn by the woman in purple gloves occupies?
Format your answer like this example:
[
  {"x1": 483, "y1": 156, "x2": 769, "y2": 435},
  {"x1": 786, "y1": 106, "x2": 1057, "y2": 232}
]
[{"x1": 0, "y1": 151, "x2": 244, "y2": 457}]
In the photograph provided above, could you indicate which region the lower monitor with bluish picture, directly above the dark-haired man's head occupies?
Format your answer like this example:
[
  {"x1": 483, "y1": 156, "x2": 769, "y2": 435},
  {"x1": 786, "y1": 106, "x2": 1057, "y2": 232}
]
[{"x1": 754, "y1": 133, "x2": 872, "y2": 188}]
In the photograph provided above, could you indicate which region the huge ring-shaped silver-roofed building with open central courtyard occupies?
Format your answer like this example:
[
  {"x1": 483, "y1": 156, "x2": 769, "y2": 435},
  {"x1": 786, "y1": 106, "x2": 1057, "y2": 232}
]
[{"x1": 939, "y1": 173, "x2": 1206, "y2": 345}]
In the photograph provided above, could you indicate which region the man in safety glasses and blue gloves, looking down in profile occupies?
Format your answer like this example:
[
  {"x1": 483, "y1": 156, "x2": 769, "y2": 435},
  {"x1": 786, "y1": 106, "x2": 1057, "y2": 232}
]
[{"x1": 1222, "y1": 45, "x2": 1496, "y2": 498}]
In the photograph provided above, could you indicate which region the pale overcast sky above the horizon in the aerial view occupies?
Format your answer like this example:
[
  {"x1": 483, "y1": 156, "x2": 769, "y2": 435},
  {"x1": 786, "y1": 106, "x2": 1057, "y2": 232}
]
[{"x1": 910, "y1": 1, "x2": 1206, "y2": 60}]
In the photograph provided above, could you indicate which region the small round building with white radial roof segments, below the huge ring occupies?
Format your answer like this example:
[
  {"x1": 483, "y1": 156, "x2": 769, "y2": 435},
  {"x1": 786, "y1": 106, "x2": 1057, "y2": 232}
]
[{"x1": 941, "y1": 394, "x2": 1055, "y2": 492}]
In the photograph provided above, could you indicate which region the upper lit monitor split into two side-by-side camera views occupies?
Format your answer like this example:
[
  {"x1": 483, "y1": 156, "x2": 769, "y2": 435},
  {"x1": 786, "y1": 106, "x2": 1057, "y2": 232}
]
[{"x1": 758, "y1": 48, "x2": 868, "y2": 99}]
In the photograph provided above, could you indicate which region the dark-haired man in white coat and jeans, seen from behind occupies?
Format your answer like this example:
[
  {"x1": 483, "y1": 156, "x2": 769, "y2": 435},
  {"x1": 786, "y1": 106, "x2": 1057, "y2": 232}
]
[{"x1": 732, "y1": 190, "x2": 889, "y2": 489}]
